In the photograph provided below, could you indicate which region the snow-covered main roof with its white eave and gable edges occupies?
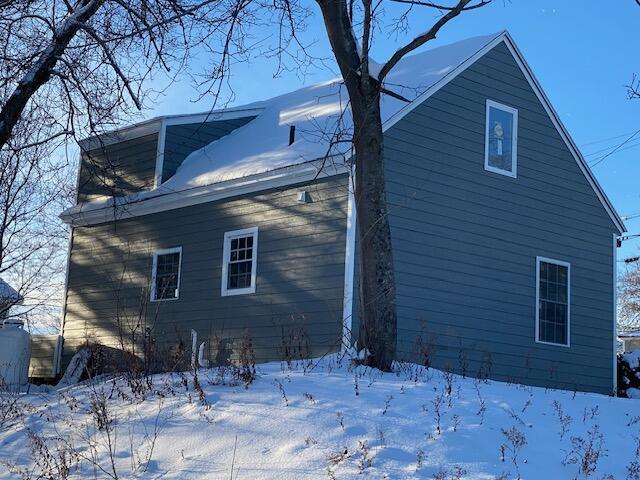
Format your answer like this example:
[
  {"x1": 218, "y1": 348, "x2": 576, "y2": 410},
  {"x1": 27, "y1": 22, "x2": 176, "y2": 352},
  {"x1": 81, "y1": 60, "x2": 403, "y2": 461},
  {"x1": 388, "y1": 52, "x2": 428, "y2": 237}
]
[{"x1": 62, "y1": 31, "x2": 625, "y2": 233}]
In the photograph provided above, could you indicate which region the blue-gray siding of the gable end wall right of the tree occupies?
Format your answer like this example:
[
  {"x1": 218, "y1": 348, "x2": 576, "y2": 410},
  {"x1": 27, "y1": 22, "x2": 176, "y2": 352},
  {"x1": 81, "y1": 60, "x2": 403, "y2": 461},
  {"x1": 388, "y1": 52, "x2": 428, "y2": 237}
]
[{"x1": 385, "y1": 44, "x2": 616, "y2": 393}]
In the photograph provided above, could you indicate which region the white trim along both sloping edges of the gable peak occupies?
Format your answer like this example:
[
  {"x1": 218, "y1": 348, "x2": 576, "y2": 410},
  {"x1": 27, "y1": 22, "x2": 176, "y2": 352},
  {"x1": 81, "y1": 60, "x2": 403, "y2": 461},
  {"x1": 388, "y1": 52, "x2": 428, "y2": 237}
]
[{"x1": 382, "y1": 30, "x2": 627, "y2": 234}]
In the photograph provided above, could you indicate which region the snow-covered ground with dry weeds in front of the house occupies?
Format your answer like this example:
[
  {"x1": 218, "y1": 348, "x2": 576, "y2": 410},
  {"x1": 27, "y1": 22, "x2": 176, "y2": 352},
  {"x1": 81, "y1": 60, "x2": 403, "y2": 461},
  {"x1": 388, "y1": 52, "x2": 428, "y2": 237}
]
[{"x1": 0, "y1": 357, "x2": 640, "y2": 480}]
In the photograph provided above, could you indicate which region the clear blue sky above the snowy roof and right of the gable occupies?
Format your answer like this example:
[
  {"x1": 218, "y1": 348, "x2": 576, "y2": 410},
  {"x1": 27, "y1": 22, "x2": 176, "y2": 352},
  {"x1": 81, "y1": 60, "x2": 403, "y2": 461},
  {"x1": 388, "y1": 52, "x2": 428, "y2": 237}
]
[{"x1": 148, "y1": 0, "x2": 640, "y2": 258}]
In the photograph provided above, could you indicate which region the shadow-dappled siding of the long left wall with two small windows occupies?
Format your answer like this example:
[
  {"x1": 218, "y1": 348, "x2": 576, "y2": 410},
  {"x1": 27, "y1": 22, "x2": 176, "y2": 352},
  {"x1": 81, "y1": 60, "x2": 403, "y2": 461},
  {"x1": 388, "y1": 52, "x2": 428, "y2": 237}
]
[{"x1": 63, "y1": 176, "x2": 347, "y2": 365}]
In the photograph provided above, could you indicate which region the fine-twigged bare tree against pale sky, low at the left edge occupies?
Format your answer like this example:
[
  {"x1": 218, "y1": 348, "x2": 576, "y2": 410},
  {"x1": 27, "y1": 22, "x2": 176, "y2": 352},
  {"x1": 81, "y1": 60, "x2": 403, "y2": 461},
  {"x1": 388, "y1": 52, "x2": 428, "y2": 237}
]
[{"x1": 0, "y1": 112, "x2": 72, "y2": 328}]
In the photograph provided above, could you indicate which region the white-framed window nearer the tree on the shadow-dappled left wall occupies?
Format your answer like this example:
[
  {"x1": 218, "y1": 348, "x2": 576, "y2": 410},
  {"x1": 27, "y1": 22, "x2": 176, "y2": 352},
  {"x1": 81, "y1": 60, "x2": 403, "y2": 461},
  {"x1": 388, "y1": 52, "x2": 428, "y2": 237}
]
[{"x1": 221, "y1": 227, "x2": 258, "y2": 296}]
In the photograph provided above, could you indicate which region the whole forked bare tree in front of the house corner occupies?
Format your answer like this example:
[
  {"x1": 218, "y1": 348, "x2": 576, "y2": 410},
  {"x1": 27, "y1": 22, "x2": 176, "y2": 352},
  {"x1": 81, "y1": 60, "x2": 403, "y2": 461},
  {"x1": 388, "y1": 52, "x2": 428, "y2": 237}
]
[{"x1": 317, "y1": 0, "x2": 491, "y2": 370}]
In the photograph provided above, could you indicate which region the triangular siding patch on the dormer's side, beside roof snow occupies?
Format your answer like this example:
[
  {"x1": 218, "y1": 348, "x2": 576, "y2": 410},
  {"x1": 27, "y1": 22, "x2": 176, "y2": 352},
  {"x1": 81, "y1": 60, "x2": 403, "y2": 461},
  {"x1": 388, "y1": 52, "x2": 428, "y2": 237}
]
[{"x1": 162, "y1": 117, "x2": 256, "y2": 182}]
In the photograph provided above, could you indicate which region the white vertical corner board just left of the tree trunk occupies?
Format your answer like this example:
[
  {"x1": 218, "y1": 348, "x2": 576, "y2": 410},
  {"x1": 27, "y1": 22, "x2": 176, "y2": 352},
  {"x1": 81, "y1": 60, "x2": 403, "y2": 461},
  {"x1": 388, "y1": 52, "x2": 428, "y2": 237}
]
[{"x1": 342, "y1": 166, "x2": 357, "y2": 352}]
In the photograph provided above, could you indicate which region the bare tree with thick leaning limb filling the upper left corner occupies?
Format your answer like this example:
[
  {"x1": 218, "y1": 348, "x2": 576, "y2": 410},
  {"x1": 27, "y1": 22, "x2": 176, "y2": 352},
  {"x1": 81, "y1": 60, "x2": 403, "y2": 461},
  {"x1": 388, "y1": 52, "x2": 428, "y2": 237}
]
[{"x1": 0, "y1": 0, "x2": 252, "y2": 330}]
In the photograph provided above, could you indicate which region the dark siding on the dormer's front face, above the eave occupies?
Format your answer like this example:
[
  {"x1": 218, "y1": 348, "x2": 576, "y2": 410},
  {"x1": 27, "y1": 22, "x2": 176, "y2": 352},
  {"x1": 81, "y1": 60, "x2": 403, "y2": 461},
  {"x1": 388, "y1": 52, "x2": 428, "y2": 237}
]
[{"x1": 78, "y1": 133, "x2": 158, "y2": 203}]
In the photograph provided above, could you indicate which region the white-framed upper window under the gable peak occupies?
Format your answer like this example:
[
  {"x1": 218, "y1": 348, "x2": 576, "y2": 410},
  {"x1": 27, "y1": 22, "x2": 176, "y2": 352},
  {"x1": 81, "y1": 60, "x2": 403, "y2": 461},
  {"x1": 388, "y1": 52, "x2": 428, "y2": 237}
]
[{"x1": 484, "y1": 100, "x2": 518, "y2": 178}]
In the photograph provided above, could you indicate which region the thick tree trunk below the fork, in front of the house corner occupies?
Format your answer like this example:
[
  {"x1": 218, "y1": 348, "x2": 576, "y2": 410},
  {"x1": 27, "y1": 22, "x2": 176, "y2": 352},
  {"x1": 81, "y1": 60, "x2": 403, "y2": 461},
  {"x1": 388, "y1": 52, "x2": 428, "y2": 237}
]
[{"x1": 354, "y1": 92, "x2": 397, "y2": 371}]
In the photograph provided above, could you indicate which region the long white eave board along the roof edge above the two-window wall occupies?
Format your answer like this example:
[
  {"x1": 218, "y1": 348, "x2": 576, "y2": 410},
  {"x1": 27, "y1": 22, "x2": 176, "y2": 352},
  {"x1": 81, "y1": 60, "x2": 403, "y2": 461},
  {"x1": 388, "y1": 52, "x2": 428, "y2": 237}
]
[{"x1": 60, "y1": 157, "x2": 350, "y2": 227}]
